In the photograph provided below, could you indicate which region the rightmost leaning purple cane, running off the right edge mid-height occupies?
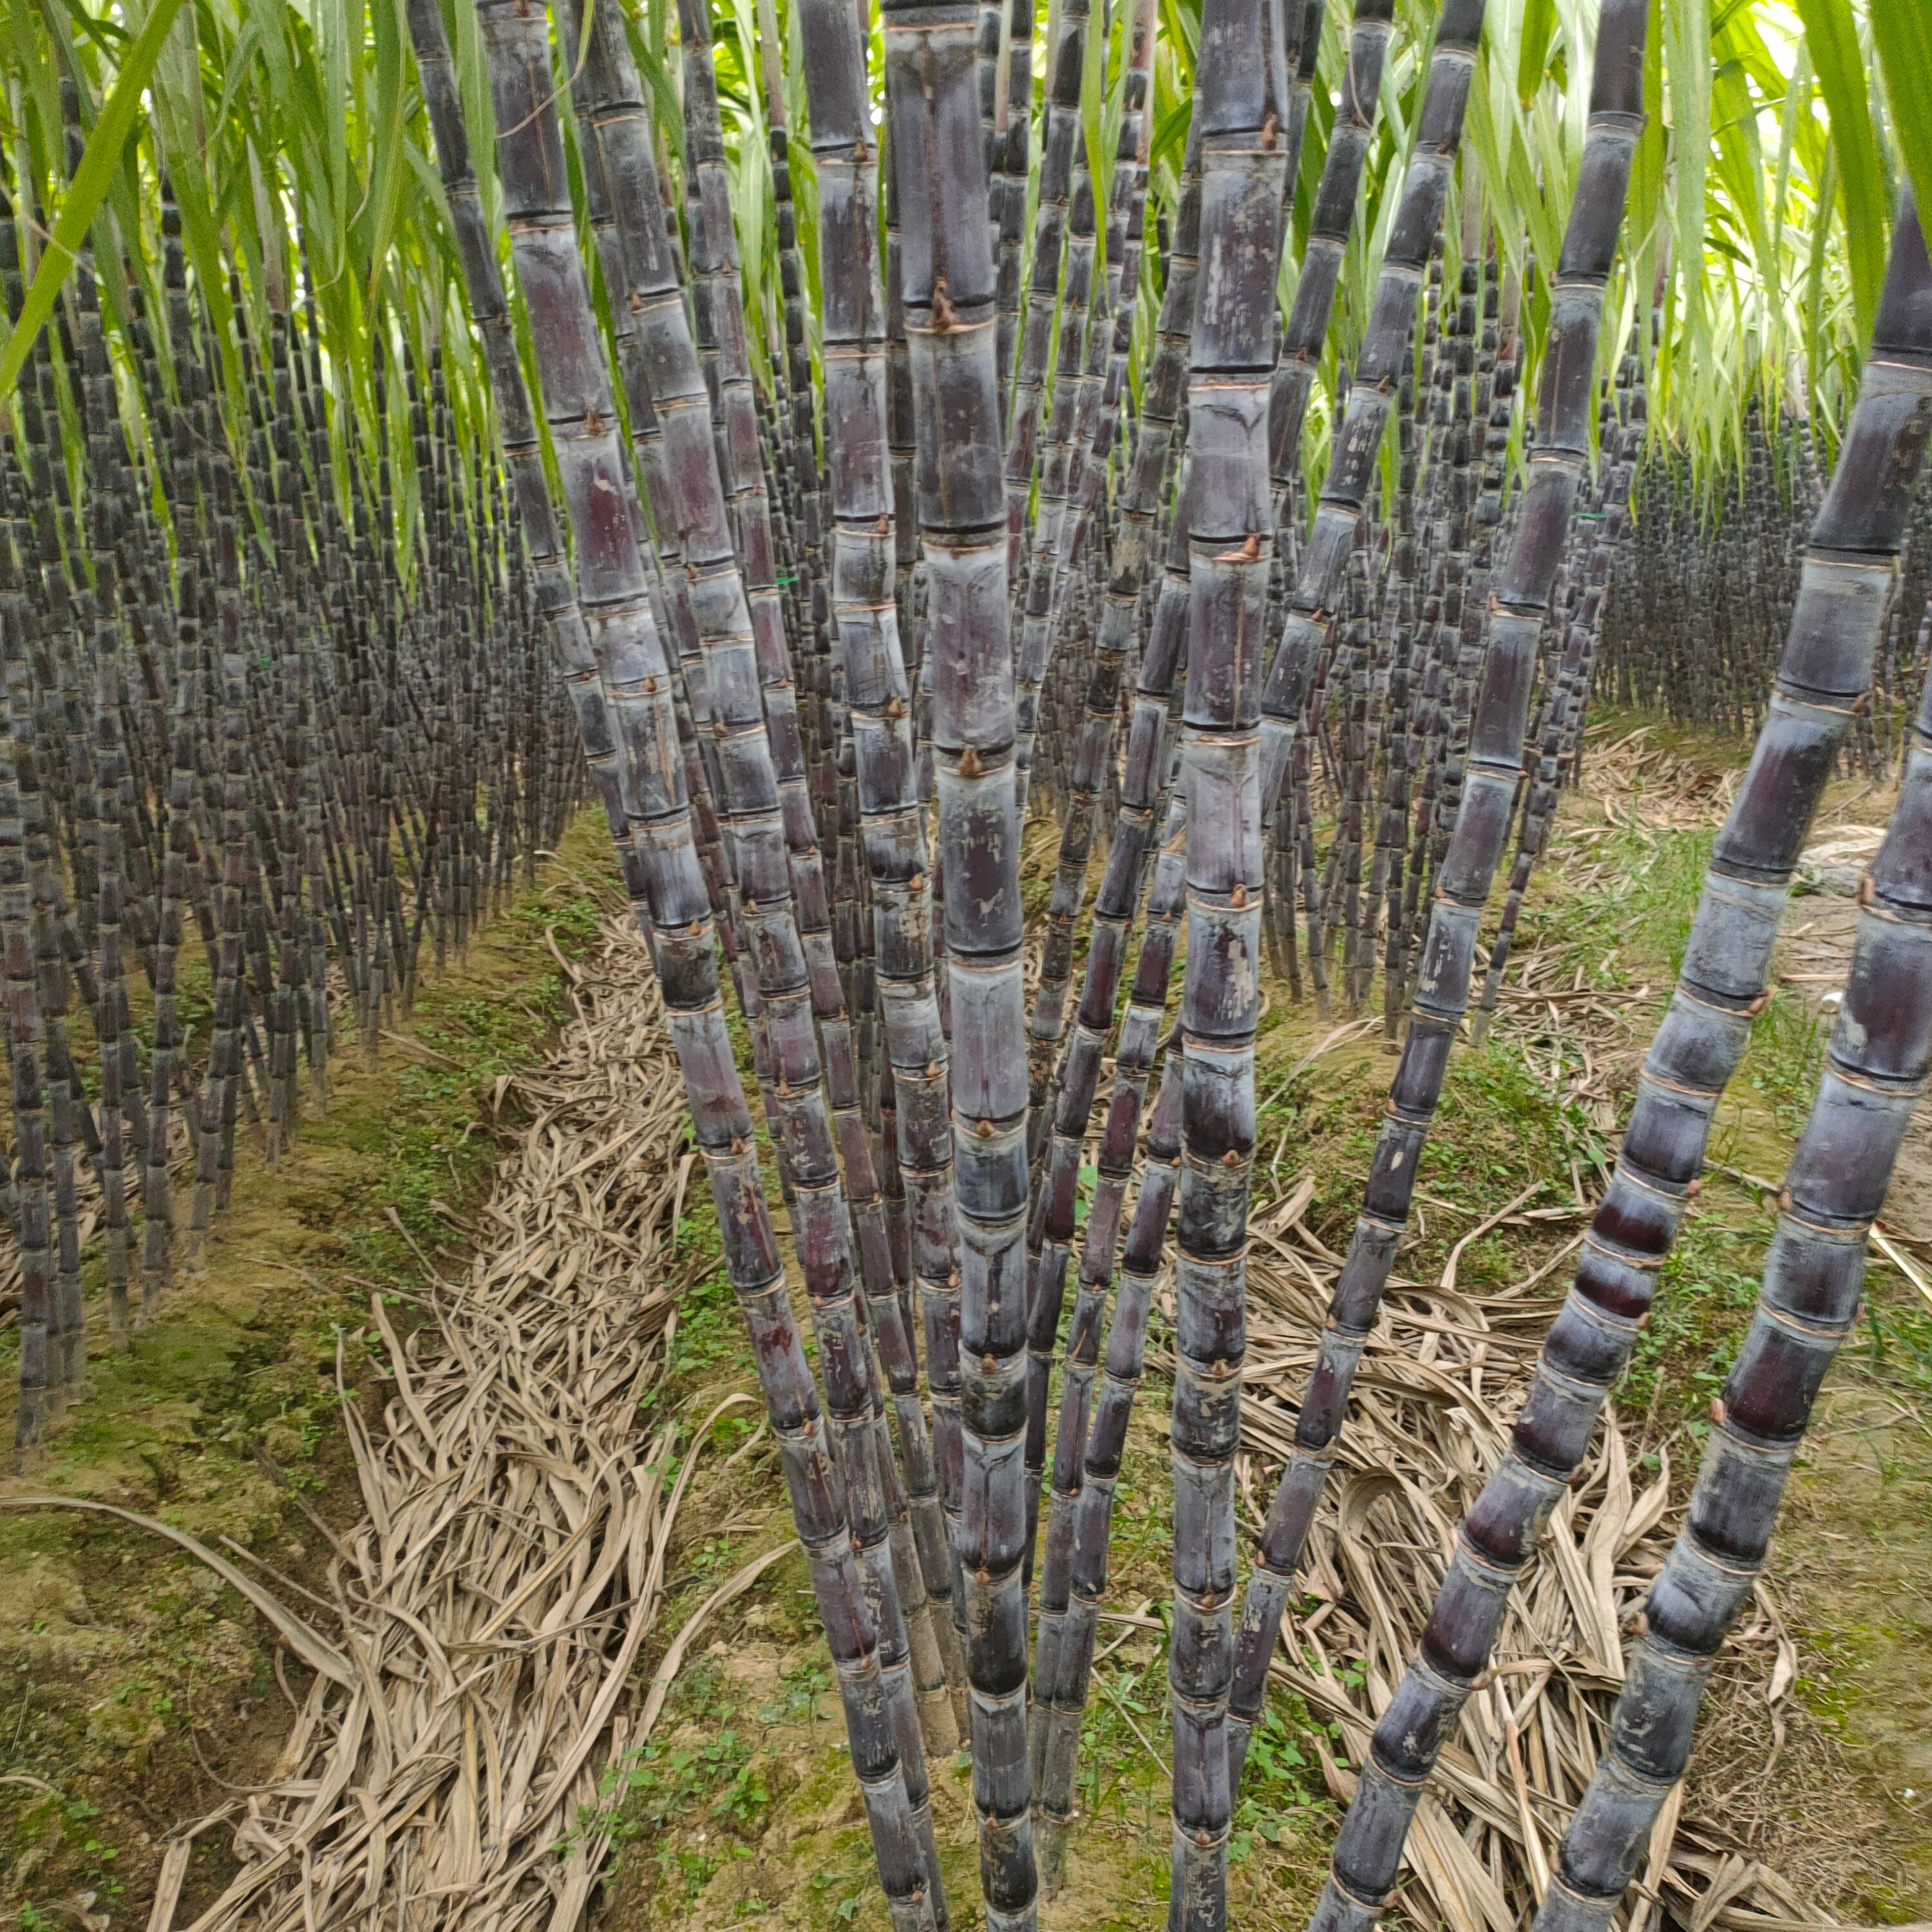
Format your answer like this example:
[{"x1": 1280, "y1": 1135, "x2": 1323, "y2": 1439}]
[{"x1": 1536, "y1": 249, "x2": 1932, "y2": 1932}]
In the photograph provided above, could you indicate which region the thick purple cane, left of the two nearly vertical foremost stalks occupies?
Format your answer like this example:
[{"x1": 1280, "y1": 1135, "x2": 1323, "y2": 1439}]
[{"x1": 885, "y1": 0, "x2": 1037, "y2": 1932}]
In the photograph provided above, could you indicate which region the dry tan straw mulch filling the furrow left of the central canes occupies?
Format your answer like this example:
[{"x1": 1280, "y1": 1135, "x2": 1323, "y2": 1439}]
[{"x1": 15, "y1": 918, "x2": 753, "y2": 1932}]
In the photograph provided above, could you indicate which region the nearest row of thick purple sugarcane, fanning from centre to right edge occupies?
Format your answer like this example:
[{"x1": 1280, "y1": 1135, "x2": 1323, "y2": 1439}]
[{"x1": 15, "y1": 0, "x2": 1932, "y2": 1932}]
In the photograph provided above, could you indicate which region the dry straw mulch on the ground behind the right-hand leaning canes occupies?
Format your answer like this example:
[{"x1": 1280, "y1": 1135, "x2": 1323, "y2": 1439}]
[{"x1": 1240, "y1": 1182, "x2": 1835, "y2": 1932}]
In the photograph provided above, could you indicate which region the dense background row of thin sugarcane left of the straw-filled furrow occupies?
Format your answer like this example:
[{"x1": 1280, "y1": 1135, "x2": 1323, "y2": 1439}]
[{"x1": 0, "y1": 83, "x2": 582, "y2": 1455}]
